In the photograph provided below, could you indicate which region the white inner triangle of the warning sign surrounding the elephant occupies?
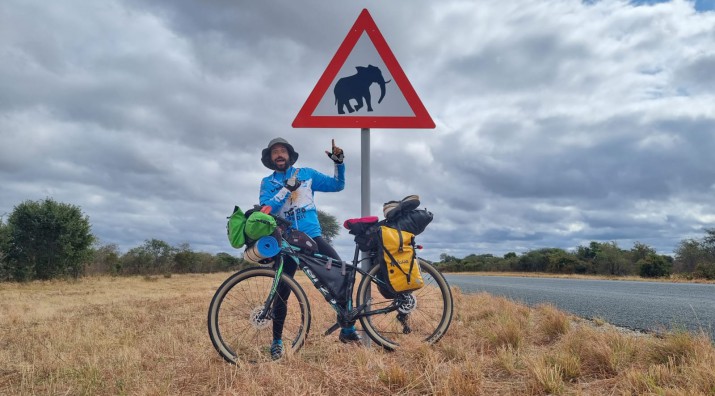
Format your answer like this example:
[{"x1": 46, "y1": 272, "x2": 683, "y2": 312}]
[{"x1": 313, "y1": 32, "x2": 415, "y2": 117}]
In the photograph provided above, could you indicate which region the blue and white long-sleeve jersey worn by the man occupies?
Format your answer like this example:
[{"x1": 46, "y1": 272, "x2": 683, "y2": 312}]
[{"x1": 259, "y1": 164, "x2": 345, "y2": 238}]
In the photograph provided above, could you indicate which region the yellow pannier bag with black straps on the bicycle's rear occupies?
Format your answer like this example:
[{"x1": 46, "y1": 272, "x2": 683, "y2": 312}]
[{"x1": 380, "y1": 225, "x2": 424, "y2": 293}]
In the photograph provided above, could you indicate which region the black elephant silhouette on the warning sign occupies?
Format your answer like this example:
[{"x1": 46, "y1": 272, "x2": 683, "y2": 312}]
[{"x1": 333, "y1": 65, "x2": 392, "y2": 114}]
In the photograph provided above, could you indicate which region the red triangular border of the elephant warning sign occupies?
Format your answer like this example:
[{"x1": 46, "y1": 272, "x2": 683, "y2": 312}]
[{"x1": 292, "y1": 9, "x2": 435, "y2": 129}]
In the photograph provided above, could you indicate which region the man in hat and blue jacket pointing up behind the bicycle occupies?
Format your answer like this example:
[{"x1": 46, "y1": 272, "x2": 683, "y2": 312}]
[{"x1": 259, "y1": 138, "x2": 360, "y2": 359}]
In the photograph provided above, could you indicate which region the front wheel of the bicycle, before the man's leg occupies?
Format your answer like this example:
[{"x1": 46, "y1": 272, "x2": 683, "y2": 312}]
[{"x1": 208, "y1": 267, "x2": 311, "y2": 365}]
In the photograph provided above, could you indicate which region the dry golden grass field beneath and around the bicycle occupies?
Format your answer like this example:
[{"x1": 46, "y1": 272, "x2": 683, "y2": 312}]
[{"x1": 0, "y1": 273, "x2": 715, "y2": 395}]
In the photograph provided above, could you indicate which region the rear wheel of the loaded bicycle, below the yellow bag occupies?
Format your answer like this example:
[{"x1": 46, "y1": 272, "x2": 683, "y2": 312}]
[{"x1": 357, "y1": 259, "x2": 454, "y2": 350}]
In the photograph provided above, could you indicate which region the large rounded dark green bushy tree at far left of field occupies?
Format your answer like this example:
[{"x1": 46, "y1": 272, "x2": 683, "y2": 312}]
[{"x1": 7, "y1": 198, "x2": 95, "y2": 281}]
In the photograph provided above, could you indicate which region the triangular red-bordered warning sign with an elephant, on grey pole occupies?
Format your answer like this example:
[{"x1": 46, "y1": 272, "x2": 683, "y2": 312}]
[{"x1": 293, "y1": 9, "x2": 435, "y2": 128}]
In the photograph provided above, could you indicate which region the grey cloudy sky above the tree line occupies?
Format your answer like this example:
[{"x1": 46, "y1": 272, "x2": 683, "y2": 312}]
[{"x1": 0, "y1": 0, "x2": 715, "y2": 259}]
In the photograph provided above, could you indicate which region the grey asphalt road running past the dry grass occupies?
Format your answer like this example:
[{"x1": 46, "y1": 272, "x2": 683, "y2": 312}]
[{"x1": 445, "y1": 274, "x2": 715, "y2": 341}]
